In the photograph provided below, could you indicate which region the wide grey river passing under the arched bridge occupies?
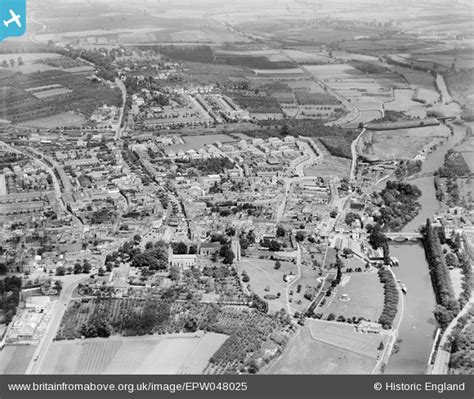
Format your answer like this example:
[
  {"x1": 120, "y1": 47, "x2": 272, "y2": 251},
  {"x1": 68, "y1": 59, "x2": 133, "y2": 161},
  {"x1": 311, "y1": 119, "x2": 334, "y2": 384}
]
[{"x1": 385, "y1": 125, "x2": 465, "y2": 374}]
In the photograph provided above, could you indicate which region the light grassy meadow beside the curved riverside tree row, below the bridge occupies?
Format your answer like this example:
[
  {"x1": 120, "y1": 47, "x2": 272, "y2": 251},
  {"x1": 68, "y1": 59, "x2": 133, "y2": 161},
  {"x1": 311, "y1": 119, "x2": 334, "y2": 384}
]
[{"x1": 314, "y1": 272, "x2": 384, "y2": 321}]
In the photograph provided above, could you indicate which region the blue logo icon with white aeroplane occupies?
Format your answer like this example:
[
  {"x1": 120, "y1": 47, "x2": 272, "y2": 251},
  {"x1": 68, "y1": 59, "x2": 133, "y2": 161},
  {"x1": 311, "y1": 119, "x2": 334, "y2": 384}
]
[{"x1": 0, "y1": 0, "x2": 26, "y2": 41}]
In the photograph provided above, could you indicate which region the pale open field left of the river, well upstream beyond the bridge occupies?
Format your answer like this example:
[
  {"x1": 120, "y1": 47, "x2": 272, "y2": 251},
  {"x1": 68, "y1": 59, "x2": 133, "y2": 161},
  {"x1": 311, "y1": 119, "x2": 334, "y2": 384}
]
[{"x1": 360, "y1": 125, "x2": 449, "y2": 159}]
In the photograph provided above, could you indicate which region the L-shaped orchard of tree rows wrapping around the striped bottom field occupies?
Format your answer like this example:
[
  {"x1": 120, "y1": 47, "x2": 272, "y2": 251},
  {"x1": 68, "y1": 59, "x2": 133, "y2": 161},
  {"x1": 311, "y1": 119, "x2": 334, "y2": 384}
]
[{"x1": 56, "y1": 299, "x2": 292, "y2": 373}]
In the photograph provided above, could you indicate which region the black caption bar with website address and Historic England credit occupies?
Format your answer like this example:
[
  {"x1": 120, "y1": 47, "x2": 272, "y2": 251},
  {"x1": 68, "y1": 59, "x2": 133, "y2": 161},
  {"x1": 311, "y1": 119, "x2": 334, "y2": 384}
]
[{"x1": 0, "y1": 375, "x2": 474, "y2": 399}]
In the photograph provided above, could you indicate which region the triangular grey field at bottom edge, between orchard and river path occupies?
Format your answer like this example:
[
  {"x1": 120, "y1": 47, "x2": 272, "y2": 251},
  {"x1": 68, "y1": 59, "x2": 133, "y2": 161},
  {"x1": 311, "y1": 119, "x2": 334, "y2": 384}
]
[{"x1": 264, "y1": 327, "x2": 376, "y2": 374}]
